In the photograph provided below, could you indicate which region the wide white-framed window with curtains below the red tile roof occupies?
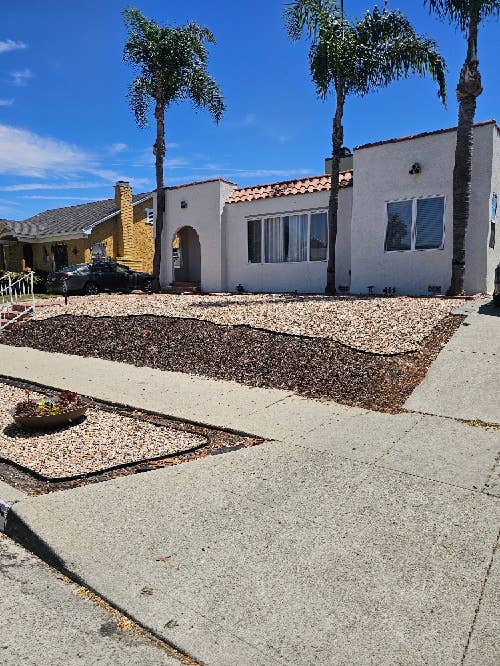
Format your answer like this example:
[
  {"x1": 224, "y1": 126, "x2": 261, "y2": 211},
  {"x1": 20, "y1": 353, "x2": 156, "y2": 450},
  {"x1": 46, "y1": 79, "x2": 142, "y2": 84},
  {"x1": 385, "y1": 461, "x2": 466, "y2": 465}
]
[{"x1": 247, "y1": 211, "x2": 328, "y2": 264}]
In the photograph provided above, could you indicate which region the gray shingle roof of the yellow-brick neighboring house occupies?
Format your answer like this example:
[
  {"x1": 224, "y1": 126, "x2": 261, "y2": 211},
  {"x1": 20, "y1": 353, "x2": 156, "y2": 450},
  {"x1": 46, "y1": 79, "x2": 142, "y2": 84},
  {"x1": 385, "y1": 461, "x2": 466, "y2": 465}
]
[{"x1": 1, "y1": 192, "x2": 153, "y2": 238}]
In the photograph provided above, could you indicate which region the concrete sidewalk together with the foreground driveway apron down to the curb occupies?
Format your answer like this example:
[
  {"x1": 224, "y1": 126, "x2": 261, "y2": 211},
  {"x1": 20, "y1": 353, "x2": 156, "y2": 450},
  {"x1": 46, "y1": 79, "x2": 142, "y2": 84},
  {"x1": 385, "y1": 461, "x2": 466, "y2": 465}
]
[{"x1": 0, "y1": 346, "x2": 500, "y2": 666}]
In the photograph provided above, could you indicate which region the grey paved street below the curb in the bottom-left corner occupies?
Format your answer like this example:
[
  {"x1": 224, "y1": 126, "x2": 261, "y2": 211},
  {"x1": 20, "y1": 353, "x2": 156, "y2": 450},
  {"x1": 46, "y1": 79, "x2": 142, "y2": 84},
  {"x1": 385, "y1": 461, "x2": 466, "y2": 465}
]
[{"x1": 0, "y1": 534, "x2": 184, "y2": 666}]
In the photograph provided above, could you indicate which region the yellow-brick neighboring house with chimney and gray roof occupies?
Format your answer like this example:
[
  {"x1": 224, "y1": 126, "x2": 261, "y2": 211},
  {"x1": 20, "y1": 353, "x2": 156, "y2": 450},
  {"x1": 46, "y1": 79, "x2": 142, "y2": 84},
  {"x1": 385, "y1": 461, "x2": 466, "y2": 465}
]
[{"x1": 0, "y1": 181, "x2": 153, "y2": 272}]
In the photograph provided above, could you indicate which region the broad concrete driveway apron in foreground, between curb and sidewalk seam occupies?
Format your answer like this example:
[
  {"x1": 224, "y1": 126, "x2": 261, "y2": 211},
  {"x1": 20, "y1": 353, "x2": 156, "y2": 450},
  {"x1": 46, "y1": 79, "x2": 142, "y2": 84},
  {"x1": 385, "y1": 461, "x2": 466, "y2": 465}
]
[{"x1": 6, "y1": 442, "x2": 500, "y2": 666}]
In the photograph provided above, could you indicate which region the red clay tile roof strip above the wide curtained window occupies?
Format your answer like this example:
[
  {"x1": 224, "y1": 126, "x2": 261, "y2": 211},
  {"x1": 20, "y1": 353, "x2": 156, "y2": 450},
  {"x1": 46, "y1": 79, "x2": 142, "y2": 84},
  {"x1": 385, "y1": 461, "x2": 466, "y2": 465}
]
[{"x1": 228, "y1": 169, "x2": 353, "y2": 203}]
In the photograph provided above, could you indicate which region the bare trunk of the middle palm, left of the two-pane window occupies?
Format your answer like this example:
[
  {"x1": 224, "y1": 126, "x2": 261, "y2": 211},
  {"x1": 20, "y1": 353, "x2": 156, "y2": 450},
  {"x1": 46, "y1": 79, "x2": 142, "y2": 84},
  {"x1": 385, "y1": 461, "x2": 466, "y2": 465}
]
[{"x1": 325, "y1": 82, "x2": 345, "y2": 295}]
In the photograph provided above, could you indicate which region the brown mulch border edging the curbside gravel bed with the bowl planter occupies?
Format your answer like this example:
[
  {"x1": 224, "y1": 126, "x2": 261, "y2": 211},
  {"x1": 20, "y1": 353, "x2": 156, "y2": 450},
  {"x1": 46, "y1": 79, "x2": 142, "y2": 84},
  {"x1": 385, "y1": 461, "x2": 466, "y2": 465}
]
[{"x1": 0, "y1": 379, "x2": 265, "y2": 495}]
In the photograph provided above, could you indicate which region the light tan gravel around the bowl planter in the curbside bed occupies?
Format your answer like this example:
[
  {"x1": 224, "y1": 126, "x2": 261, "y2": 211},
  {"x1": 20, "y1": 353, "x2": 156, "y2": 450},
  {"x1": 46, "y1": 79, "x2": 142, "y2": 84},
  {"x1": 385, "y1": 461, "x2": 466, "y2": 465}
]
[{"x1": 0, "y1": 382, "x2": 206, "y2": 479}]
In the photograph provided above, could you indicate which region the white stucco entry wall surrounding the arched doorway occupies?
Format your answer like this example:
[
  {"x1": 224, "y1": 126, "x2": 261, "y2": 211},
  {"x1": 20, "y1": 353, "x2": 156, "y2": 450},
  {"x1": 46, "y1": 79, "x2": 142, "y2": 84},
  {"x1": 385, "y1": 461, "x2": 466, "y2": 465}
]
[{"x1": 160, "y1": 181, "x2": 237, "y2": 291}]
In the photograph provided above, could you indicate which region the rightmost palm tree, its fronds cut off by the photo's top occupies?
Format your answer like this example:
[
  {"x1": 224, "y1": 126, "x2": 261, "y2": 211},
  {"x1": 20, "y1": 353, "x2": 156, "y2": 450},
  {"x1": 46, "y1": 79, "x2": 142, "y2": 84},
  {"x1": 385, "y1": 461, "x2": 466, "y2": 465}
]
[{"x1": 424, "y1": 0, "x2": 500, "y2": 296}]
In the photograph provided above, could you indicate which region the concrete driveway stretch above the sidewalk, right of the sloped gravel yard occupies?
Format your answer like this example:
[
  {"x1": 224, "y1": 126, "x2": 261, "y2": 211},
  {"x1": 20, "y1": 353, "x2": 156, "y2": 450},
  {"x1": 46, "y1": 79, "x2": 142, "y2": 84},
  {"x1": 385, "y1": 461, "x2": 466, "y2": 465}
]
[{"x1": 405, "y1": 302, "x2": 500, "y2": 424}]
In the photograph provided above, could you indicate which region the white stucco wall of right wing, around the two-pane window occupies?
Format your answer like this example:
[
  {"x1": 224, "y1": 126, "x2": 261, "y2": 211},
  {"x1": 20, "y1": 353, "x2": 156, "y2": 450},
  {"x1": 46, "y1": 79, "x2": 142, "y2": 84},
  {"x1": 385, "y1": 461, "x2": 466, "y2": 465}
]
[{"x1": 351, "y1": 124, "x2": 495, "y2": 295}]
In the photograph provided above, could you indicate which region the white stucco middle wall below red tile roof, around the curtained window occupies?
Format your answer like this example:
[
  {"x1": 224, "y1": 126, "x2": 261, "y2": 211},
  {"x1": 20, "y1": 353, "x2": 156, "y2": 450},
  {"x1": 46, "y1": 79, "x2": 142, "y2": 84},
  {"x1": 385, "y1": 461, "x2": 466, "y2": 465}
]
[{"x1": 223, "y1": 187, "x2": 352, "y2": 293}]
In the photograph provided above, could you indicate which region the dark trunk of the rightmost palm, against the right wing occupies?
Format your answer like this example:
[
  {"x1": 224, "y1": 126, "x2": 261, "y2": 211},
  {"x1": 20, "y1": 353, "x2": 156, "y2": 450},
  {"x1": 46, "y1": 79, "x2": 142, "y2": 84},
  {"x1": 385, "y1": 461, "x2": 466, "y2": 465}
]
[{"x1": 448, "y1": 14, "x2": 483, "y2": 296}]
